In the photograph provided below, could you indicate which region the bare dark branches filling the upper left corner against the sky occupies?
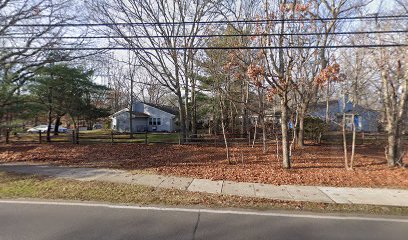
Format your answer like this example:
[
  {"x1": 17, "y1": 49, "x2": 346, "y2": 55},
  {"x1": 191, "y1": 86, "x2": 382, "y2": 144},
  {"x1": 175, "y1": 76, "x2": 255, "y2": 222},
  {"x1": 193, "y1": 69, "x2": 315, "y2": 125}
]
[{"x1": 0, "y1": 0, "x2": 64, "y2": 107}]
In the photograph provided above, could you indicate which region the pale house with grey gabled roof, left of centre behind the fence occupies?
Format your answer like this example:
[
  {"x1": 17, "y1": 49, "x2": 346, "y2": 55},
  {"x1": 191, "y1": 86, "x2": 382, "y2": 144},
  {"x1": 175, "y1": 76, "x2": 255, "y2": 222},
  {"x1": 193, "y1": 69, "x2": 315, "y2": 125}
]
[{"x1": 111, "y1": 102, "x2": 177, "y2": 132}]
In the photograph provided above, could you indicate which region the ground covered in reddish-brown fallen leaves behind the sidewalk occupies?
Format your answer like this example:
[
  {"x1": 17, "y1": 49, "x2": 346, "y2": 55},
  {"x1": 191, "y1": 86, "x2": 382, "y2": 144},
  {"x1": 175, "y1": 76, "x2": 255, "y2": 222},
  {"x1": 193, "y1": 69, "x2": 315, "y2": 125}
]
[{"x1": 0, "y1": 144, "x2": 408, "y2": 188}]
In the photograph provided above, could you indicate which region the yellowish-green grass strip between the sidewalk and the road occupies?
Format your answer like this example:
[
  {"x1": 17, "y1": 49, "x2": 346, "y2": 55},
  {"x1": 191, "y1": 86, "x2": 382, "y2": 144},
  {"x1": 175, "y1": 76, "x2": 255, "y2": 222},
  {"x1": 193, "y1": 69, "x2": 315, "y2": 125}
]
[{"x1": 0, "y1": 172, "x2": 408, "y2": 216}]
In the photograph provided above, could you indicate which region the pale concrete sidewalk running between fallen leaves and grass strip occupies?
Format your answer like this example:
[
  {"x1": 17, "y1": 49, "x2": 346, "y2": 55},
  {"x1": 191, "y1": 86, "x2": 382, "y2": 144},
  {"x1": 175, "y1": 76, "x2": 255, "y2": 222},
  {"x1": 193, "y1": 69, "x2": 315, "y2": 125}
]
[{"x1": 0, "y1": 163, "x2": 408, "y2": 207}]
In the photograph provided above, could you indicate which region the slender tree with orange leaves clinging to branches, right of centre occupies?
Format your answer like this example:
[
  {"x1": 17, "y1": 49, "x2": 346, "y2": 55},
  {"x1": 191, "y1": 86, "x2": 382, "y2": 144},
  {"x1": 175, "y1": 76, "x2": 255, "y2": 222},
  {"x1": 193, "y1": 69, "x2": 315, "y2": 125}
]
[{"x1": 248, "y1": 0, "x2": 308, "y2": 168}]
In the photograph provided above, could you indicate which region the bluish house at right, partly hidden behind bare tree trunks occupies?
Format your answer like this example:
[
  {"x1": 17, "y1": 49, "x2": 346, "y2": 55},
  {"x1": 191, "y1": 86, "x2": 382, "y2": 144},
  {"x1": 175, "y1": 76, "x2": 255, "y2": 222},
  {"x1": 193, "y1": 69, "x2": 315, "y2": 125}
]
[{"x1": 309, "y1": 97, "x2": 381, "y2": 132}]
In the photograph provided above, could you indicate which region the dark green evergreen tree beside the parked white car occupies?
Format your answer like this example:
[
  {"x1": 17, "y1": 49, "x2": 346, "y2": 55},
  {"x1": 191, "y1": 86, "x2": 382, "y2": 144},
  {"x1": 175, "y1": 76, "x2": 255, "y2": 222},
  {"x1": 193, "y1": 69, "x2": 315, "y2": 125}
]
[{"x1": 29, "y1": 64, "x2": 107, "y2": 141}]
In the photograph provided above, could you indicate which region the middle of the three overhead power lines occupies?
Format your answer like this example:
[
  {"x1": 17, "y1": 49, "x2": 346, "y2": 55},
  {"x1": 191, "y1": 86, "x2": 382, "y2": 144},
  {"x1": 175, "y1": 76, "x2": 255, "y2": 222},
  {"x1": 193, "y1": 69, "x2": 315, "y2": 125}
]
[{"x1": 2, "y1": 30, "x2": 408, "y2": 39}]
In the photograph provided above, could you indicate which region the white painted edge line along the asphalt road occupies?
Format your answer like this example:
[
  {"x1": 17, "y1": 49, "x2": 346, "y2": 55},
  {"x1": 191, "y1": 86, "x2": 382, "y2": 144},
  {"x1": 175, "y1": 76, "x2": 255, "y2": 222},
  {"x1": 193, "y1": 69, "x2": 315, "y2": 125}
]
[{"x1": 0, "y1": 200, "x2": 408, "y2": 223}]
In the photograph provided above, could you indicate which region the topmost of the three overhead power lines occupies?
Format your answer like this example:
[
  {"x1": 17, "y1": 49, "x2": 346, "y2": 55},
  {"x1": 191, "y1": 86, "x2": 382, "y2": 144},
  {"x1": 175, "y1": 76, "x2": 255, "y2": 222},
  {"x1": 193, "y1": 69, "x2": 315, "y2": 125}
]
[{"x1": 0, "y1": 15, "x2": 408, "y2": 27}]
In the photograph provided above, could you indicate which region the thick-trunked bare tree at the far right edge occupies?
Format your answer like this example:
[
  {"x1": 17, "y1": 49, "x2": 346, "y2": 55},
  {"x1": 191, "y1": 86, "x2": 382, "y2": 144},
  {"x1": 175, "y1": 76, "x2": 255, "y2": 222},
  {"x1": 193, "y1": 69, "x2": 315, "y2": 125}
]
[{"x1": 371, "y1": 0, "x2": 408, "y2": 167}]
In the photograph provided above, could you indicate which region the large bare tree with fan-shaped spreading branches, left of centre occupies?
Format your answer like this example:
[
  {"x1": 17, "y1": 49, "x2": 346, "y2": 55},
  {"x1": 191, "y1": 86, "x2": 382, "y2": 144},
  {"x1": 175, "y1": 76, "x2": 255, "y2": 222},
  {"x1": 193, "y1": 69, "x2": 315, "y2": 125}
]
[{"x1": 90, "y1": 0, "x2": 218, "y2": 139}]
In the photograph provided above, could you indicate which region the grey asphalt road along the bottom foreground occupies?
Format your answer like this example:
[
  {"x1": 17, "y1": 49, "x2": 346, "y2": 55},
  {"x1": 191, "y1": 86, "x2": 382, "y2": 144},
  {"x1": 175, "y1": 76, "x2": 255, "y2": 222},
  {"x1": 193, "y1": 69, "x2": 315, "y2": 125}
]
[{"x1": 0, "y1": 200, "x2": 408, "y2": 240}]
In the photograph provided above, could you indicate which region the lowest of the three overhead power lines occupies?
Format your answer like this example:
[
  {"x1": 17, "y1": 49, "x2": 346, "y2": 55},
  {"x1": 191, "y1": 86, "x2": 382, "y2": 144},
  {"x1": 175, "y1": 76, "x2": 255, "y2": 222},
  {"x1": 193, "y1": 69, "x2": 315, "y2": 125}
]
[{"x1": 0, "y1": 43, "x2": 408, "y2": 51}]
